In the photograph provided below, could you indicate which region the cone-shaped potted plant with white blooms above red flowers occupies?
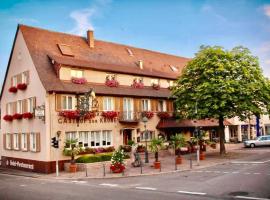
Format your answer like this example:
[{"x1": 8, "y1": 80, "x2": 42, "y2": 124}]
[{"x1": 110, "y1": 149, "x2": 125, "y2": 173}]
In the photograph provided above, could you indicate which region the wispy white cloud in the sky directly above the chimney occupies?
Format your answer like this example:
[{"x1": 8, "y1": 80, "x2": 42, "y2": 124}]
[{"x1": 70, "y1": 0, "x2": 111, "y2": 35}]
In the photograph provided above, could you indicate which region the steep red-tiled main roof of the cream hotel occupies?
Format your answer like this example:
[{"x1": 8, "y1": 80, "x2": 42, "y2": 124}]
[{"x1": 15, "y1": 25, "x2": 190, "y2": 96}]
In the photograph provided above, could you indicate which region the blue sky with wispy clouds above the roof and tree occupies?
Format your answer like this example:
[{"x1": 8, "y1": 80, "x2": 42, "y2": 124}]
[{"x1": 0, "y1": 0, "x2": 270, "y2": 82}]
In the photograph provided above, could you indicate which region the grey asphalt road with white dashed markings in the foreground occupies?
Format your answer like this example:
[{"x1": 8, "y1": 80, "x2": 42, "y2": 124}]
[{"x1": 0, "y1": 149, "x2": 270, "y2": 200}]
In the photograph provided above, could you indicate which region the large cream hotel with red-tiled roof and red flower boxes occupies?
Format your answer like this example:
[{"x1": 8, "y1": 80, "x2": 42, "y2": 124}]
[{"x1": 0, "y1": 25, "x2": 270, "y2": 173}]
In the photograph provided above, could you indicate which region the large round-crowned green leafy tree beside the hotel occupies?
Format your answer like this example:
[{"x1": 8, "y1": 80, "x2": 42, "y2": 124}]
[{"x1": 172, "y1": 46, "x2": 270, "y2": 155}]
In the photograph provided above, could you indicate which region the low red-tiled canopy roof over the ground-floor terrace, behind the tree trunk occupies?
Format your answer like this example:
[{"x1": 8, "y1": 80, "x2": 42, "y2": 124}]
[{"x1": 157, "y1": 118, "x2": 232, "y2": 129}]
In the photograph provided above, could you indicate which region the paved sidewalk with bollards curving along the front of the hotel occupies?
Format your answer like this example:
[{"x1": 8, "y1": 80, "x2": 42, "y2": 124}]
[{"x1": 0, "y1": 143, "x2": 266, "y2": 180}]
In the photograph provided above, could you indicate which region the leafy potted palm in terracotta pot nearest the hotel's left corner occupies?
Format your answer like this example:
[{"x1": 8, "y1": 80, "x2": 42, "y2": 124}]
[{"x1": 64, "y1": 139, "x2": 80, "y2": 173}]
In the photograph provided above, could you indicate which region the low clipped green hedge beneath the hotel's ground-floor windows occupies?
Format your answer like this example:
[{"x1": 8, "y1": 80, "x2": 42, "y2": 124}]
[{"x1": 76, "y1": 153, "x2": 129, "y2": 163}]
